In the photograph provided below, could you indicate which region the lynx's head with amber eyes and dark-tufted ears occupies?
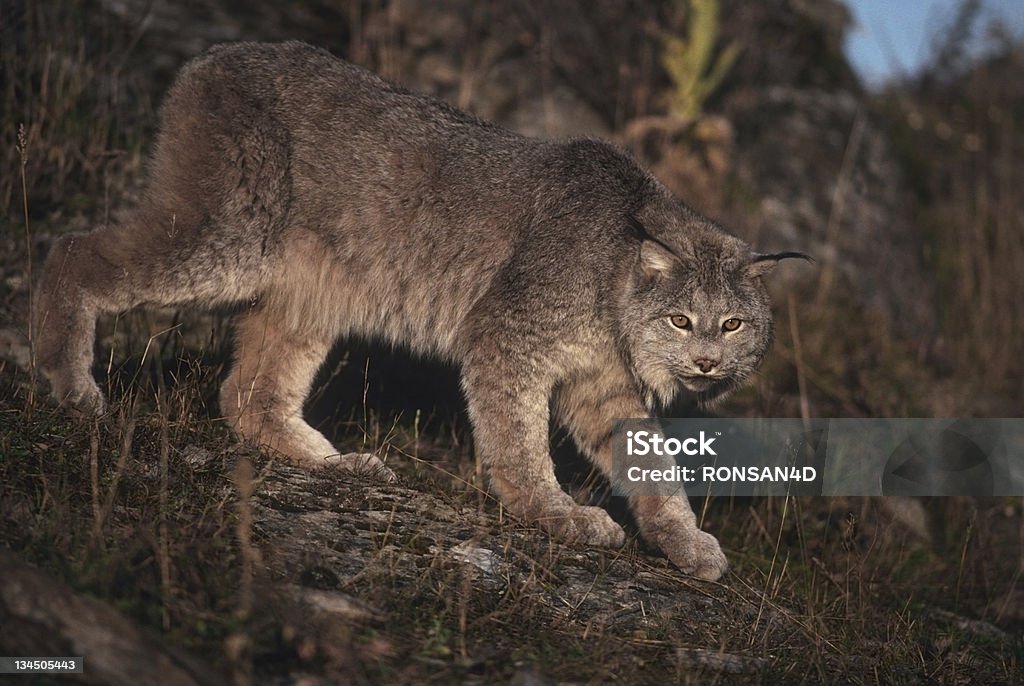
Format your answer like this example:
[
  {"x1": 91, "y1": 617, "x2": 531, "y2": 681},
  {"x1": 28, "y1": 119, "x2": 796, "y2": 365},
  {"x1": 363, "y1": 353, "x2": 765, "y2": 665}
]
[{"x1": 623, "y1": 218, "x2": 809, "y2": 405}]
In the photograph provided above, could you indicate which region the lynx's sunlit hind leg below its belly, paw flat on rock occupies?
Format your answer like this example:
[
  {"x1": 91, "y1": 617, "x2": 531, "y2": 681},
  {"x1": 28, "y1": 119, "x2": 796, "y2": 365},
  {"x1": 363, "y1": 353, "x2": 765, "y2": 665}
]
[{"x1": 220, "y1": 306, "x2": 395, "y2": 481}]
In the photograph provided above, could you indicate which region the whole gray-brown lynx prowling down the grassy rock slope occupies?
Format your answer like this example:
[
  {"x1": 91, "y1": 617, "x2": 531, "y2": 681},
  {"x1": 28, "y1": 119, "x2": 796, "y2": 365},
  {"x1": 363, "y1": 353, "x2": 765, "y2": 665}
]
[{"x1": 34, "y1": 42, "x2": 802, "y2": 580}]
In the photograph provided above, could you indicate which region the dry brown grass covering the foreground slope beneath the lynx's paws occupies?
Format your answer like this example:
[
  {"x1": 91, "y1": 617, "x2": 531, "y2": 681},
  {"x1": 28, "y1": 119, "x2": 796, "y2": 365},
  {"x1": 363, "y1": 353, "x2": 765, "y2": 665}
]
[{"x1": 0, "y1": 368, "x2": 1024, "y2": 683}]
